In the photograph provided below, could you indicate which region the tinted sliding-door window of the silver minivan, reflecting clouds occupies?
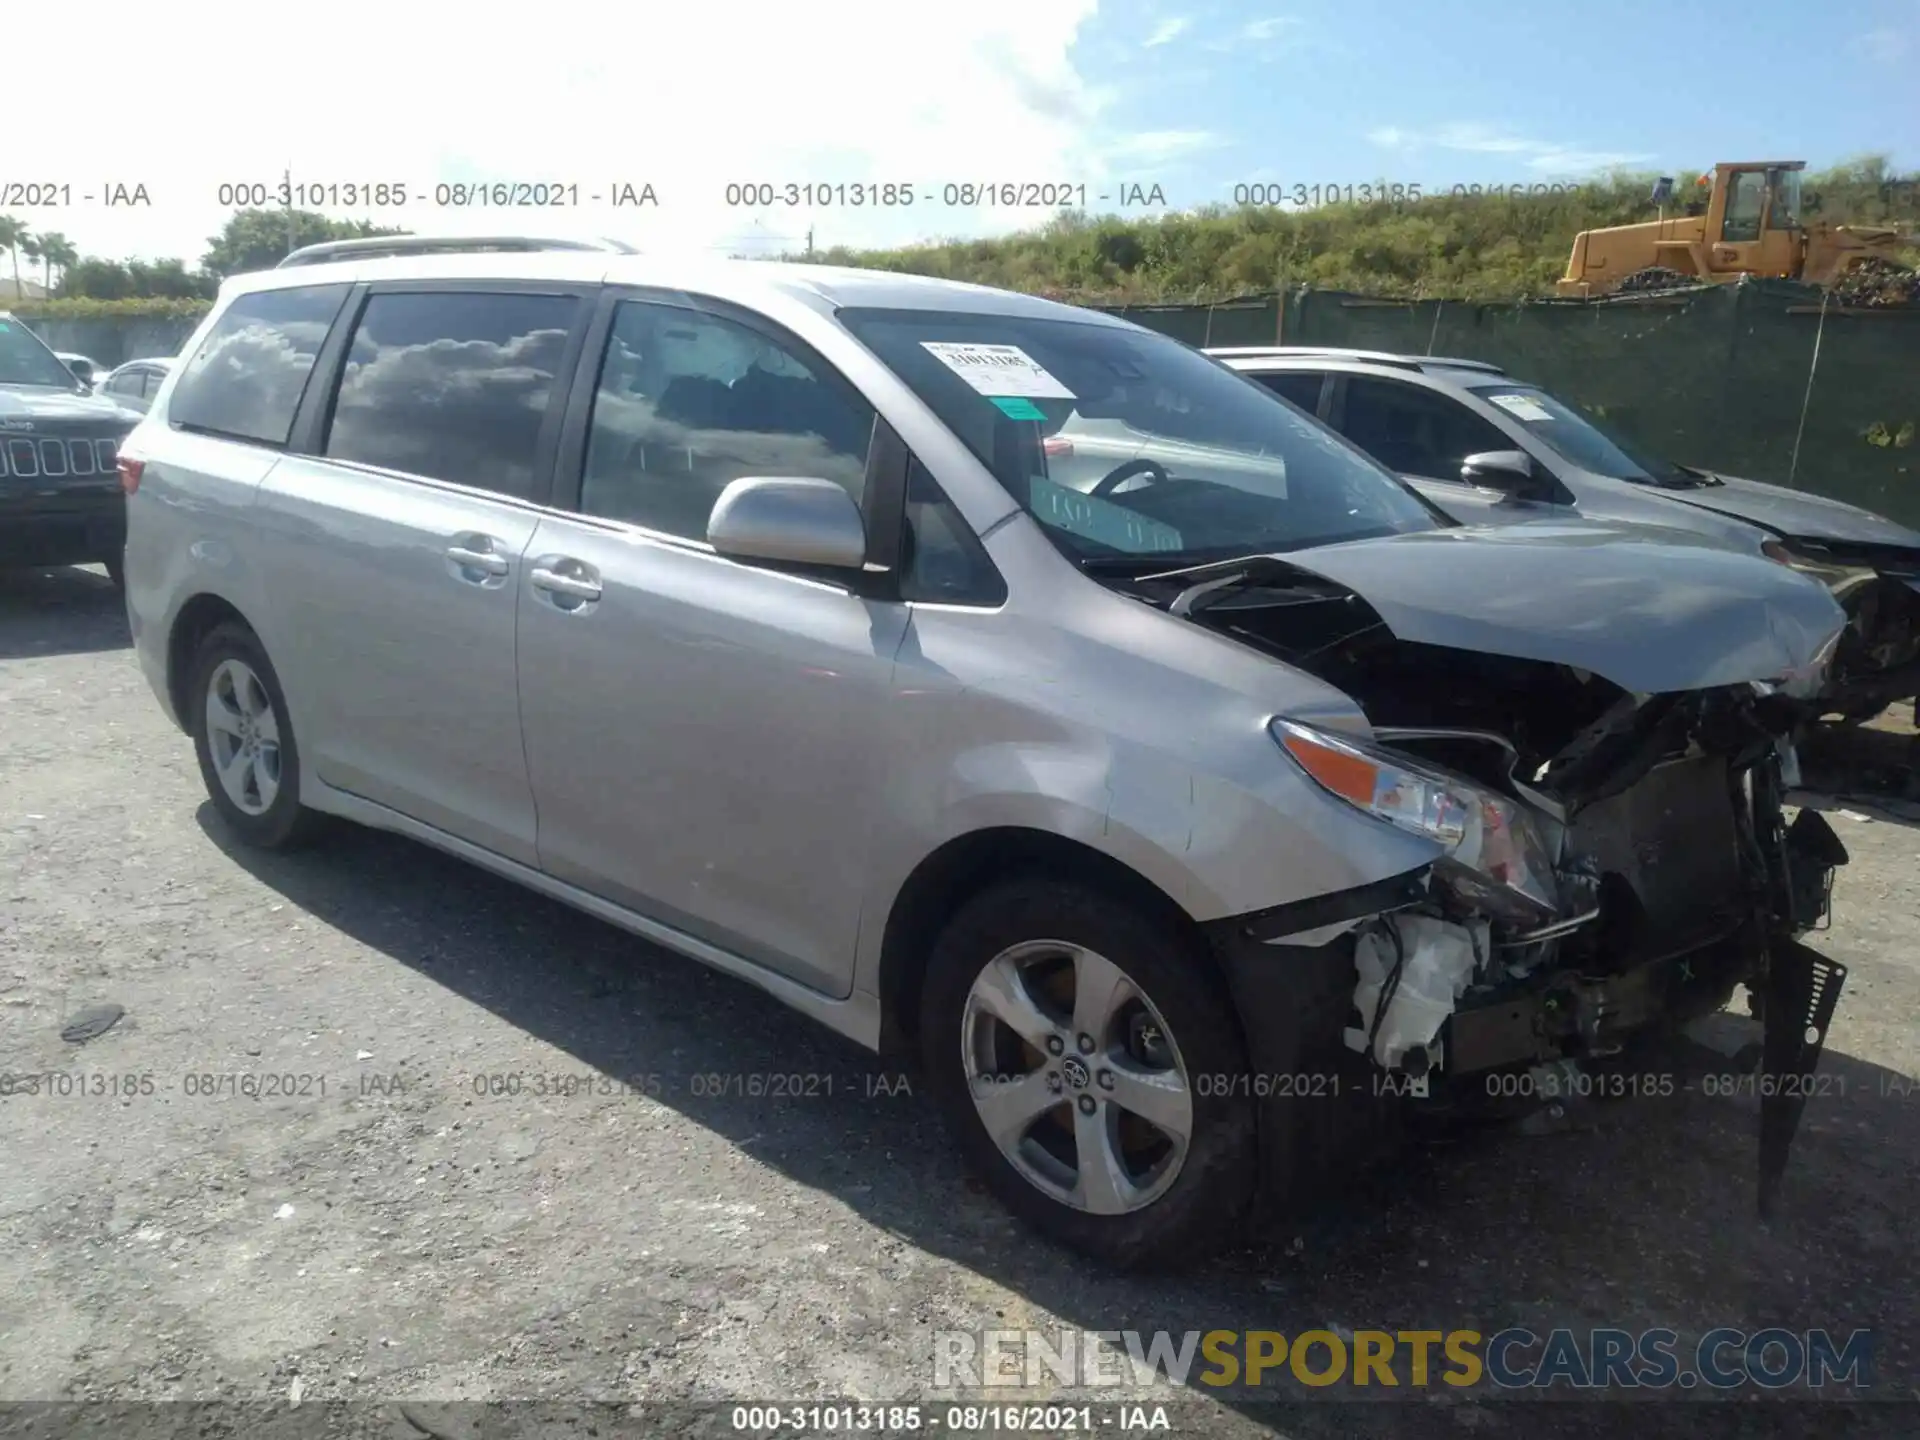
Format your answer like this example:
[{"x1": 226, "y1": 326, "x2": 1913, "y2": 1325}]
[{"x1": 324, "y1": 290, "x2": 580, "y2": 497}]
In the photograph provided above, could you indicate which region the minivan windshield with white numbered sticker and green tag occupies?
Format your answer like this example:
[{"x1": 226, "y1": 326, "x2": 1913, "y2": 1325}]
[{"x1": 839, "y1": 309, "x2": 1444, "y2": 566}]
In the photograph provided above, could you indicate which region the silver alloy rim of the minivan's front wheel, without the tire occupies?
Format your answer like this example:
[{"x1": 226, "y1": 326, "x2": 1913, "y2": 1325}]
[{"x1": 960, "y1": 941, "x2": 1194, "y2": 1215}]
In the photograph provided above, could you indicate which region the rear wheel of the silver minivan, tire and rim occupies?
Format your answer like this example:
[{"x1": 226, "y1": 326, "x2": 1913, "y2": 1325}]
[{"x1": 186, "y1": 624, "x2": 321, "y2": 851}]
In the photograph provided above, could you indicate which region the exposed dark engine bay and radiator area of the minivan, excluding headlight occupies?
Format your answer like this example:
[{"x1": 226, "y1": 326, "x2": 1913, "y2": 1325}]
[{"x1": 1121, "y1": 557, "x2": 1847, "y2": 1213}]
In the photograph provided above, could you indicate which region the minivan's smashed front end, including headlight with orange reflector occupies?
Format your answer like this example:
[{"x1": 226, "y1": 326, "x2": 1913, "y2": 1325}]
[{"x1": 1129, "y1": 547, "x2": 1847, "y2": 1215}]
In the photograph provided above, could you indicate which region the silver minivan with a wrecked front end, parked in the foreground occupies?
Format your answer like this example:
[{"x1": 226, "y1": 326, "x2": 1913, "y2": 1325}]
[{"x1": 121, "y1": 240, "x2": 1845, "y2": 1265}]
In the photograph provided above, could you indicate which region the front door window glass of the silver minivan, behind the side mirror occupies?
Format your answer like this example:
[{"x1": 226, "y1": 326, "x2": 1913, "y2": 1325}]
[{"x1": 580, "y1": 300, "x2": 874, "y2": 540}]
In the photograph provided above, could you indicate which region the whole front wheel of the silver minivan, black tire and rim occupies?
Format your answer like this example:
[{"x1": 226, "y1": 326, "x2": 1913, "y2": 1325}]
[{"x1": 920, "y1": 881, "x2": 1258, "y2": 1269}]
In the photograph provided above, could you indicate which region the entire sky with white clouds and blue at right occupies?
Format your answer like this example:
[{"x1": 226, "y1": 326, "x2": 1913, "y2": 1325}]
[{"x1": 0, "y1": 0, "x2": 1920, "y2": 265}]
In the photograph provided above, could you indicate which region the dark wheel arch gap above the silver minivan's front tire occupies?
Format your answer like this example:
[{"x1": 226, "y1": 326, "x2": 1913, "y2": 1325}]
[{"x1": 879, "y1": 826, "x2": 1225, "y2": 1052}]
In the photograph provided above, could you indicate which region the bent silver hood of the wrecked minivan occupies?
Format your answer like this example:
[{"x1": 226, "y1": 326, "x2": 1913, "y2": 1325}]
[{"x1": 1277, "y1": 524, "x2": 1845, "y2": 693}]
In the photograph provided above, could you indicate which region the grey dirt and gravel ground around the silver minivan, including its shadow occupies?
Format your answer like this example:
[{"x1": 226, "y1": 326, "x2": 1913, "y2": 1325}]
[{"x1": 0, "y1": 570, "x2": 1920, "y2": 1436}]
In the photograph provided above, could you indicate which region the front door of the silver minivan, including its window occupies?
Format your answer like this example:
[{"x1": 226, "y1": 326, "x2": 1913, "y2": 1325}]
[{"x1": 518, "y1": 300, "x2": 906, "y2": 996}]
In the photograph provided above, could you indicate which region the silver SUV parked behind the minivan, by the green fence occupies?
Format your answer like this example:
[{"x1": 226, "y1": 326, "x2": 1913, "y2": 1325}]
[{"x1": 1208, "y1": 348, "x2": 1920, "y2": 722}]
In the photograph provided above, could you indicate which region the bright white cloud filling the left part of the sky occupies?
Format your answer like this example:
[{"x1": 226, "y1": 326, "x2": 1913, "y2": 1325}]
[{"x1": 0, "y1": 0, "x2": 1121, "y2": 261}]
